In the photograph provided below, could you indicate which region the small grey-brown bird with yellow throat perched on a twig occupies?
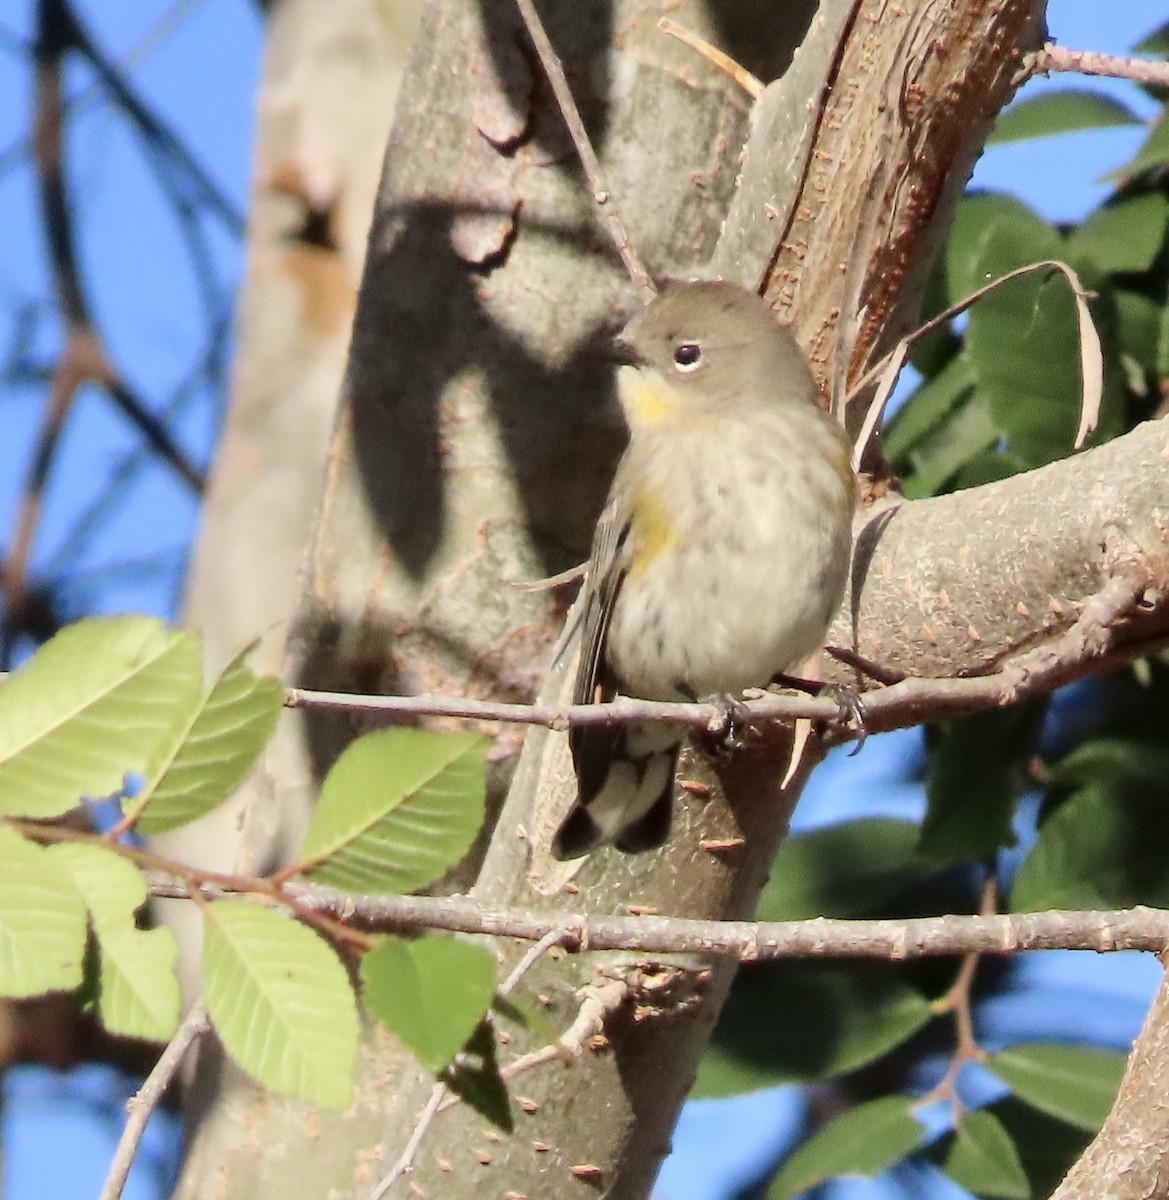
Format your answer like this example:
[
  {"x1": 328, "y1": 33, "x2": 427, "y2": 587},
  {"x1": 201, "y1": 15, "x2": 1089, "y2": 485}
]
[{"x1": 552, "y1": 282, "x2": 856, "y2": 859}]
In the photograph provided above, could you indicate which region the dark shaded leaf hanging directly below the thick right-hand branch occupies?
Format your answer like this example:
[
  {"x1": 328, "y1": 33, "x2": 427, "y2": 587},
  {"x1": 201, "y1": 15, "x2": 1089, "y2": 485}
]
[{"x1": 918, "y1": 702, "x2": 1047, "y2": 860}]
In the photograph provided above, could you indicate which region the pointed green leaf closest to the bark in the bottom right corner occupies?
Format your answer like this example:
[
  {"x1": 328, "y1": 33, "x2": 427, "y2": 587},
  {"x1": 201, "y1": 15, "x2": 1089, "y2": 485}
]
[{"x1": 985, "y1": 1042, "x2": 1125, "y2": 1133}]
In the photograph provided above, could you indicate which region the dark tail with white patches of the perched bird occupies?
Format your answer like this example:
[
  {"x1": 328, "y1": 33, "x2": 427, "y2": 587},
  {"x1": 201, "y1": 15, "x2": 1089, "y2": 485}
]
[{"x1": 552, "y1": 721, "x2": 682, "y2": 862}]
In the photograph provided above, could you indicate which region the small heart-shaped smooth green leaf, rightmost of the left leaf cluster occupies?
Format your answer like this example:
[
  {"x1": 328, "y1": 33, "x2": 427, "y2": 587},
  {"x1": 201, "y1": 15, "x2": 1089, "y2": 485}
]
[{"x1": 361, "y1": 937, "x2": 496, "y2": 1074}]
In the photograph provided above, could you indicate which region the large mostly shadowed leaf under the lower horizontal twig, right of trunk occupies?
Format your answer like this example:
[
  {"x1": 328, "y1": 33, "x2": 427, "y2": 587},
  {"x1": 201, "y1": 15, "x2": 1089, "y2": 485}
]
[{"x1": 694, "y1": 962, "x2": 934, "y2": 1096}]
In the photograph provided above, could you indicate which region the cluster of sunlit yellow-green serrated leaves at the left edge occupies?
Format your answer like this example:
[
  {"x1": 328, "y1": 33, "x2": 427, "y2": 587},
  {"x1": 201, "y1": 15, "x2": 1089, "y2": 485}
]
[{"x1": 0, "y1": 617, "x2": 496, "y2": 1108}]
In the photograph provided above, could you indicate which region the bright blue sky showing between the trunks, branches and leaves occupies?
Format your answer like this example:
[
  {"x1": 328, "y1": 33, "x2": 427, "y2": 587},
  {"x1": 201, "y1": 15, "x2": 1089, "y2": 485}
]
[{"x1": 0, "y1": 0, "x2": 1169, "y2": 1200}]
